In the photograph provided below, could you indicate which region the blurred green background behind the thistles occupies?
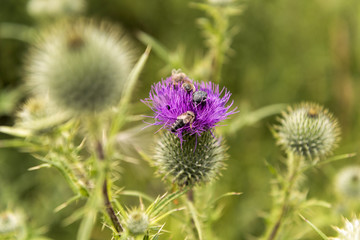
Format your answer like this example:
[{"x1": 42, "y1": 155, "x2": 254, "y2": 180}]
[{"x1": 0, "y1": 0, "x2": 360, "y2": 240}]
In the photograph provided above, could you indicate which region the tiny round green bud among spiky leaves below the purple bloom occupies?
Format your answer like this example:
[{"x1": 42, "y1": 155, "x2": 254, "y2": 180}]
[{"x1": 126, "y1": 209, "x2": 149, "y2": 235}]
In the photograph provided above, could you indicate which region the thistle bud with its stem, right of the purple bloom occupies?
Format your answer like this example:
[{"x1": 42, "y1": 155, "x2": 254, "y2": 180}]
[{"x1": 262, "y1": 103, "x2": 340, "y2": 240}]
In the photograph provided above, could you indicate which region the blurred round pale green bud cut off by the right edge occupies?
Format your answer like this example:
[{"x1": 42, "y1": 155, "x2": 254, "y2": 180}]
[{"x1": 335, "y1": 166, "x2": 360, "y2": 199}]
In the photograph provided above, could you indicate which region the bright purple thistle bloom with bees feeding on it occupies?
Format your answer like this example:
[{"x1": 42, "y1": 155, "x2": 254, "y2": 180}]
[{"x1": 141, "y1": 75, "x2": 236, "y2": 140}]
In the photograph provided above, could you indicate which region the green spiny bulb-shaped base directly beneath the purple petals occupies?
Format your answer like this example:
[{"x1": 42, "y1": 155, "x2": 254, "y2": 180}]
[{"x1": 154, "y1": 131, "x2": 227, "y2": 186}]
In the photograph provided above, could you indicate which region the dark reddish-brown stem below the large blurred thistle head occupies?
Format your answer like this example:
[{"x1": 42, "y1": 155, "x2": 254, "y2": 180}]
[{"x1": 96, "y1": 141, "x2": 124, "y2": 235}]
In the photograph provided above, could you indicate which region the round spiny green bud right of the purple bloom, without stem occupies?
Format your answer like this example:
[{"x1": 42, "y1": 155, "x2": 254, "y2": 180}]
[{"x1": 275, "y1": 103, "x2": 340, "y2": 159}]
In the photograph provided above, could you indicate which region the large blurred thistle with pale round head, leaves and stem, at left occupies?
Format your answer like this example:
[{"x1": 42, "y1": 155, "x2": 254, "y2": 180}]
[{"x1": 1, "y1": 19, "x2": 155, "y2": 240}]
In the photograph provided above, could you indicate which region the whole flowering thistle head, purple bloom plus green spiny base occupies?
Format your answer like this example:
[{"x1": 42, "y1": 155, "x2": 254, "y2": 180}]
[{"x1": 143, "y1": 70, "x2": 236, "y2": 186}]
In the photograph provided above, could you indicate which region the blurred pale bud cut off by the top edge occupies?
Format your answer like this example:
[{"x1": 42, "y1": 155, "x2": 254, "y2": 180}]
[{"x1": 27, "y1": 0, "x2": 85, "y2": 19}]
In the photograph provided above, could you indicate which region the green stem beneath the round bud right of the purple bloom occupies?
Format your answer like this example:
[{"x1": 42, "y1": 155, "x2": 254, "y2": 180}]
[{"x1": 265, "y1": 153, "x2": 301, "y2": 240}]
